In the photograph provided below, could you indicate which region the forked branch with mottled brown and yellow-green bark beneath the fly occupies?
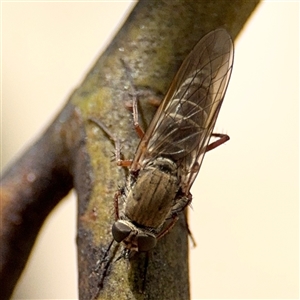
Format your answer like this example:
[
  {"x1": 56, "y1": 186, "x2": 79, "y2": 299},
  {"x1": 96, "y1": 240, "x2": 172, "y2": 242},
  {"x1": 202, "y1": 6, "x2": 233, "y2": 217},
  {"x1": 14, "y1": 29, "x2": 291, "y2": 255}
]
[{"x1": 0, "y1": 0, "x2": 259, "y2": 300}]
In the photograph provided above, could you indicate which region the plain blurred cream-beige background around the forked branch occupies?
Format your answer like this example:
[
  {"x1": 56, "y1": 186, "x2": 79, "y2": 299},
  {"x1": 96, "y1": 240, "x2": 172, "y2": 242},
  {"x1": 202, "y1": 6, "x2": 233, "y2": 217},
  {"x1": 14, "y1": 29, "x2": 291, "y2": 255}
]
[{"x1": 1, "y1": 1, "x2": 299, "y2": 299}]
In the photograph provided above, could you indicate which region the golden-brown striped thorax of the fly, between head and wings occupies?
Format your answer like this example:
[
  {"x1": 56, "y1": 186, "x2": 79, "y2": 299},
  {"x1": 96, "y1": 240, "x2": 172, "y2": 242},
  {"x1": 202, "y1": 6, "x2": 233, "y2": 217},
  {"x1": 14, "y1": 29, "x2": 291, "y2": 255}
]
[{"x1": 125, "y1": 157, "x2": 179, "y2": 231}]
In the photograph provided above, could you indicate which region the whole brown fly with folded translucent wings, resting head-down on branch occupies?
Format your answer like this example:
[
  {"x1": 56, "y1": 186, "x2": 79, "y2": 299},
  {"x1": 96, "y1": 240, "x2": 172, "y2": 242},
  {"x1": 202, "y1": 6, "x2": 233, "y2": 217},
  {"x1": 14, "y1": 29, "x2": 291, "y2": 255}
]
[{"x1": 95, "y1": 29, "x2": 234, "y2": 257}]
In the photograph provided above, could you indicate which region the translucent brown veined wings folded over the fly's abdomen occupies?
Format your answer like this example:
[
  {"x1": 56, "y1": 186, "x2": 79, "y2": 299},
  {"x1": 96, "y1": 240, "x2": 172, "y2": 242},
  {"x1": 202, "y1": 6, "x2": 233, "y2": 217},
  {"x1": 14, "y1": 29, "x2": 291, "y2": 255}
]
[{"x1": 132, "y1": 29, "x2": 233, "y2": 194}]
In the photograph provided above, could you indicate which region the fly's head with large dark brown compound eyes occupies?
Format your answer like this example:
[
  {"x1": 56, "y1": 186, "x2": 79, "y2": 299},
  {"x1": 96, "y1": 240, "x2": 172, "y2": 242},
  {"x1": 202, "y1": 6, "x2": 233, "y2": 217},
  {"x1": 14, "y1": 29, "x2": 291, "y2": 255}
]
[{"x1": 112, "y1": 220, "x2": 156, "y2": 252}]
